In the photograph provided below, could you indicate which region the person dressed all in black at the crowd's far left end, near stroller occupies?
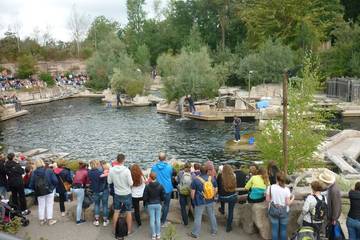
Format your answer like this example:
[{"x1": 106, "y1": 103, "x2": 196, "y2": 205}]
[{"x1": 5, "y1": 153, "x2": 30, "y2": 214}]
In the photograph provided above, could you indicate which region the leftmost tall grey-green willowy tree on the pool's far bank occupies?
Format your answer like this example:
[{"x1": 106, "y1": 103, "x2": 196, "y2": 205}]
[{"x1": 86, "y1": 34, "x2": 126, "y2": 90}]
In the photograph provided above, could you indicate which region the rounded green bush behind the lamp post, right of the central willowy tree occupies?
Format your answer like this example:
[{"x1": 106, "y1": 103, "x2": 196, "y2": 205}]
[{"x1": 237, "y1": 40, "x2": 295, "y2": 86}]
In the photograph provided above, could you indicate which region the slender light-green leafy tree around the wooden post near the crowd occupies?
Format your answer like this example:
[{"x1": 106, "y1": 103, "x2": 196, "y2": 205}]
[{"x1": 257, "y1": 54, "x2": 327, "y2": 173}]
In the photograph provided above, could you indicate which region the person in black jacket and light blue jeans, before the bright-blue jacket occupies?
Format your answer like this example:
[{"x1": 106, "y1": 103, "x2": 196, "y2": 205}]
[{"x1": 143, "y1": 172, "x2": 165, "y2": 240}]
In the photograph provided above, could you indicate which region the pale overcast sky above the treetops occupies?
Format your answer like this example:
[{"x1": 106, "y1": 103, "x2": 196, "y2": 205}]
[{"x1": 0, "y1": 0, "x2": 168, "y2": 41}]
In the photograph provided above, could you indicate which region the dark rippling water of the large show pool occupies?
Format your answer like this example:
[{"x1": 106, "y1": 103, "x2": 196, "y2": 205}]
[{"x1": 0, "y1": 98, "x2": 259, "y2": 166}]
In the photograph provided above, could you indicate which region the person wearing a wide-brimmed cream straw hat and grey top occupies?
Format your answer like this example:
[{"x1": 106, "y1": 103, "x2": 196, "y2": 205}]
[{"x1": 319, "y1": 169, "x2": 341, "y2": 234}]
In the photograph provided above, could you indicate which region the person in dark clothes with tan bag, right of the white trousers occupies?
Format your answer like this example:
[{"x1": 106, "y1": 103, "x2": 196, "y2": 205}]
[{"x1": 54, "y1": 160, "x2": 72, "y2": 217}]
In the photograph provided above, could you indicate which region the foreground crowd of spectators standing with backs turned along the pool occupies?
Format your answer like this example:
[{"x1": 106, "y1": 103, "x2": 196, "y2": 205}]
[{"x1": 0, "y1": 152, "x2": 360, "y2": 240}]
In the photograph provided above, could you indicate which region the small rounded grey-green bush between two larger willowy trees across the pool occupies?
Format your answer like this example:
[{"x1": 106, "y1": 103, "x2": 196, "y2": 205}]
[{"x1": 111, "y1": 55, "x2": 149, "y2": 97}]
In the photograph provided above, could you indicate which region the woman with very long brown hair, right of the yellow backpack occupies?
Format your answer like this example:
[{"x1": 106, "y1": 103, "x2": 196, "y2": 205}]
[{"x1": 217, "y1": 165, "x2": 237, "y2": 232}]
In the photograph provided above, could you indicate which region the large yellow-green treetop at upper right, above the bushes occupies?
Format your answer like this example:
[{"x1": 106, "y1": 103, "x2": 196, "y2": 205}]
[{"x1": 239, "y1": 0, "x2": 343, "y2": 49}]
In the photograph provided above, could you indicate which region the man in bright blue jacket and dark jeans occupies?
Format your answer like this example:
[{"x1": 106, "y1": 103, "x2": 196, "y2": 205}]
[{"x1": 151, "y1": 152, "x2": 173, "y2": 225}]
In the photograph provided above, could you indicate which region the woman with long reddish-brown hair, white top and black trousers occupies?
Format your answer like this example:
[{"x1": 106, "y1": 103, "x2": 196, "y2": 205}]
[{"x1": 130, "y1": 164, "x2": 146, "y2": 226}]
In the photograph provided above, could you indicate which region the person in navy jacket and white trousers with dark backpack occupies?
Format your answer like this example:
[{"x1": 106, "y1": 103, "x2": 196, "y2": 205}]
[{"x1": 29, "y1": 159, "x2": 58, "y2": 226}]
